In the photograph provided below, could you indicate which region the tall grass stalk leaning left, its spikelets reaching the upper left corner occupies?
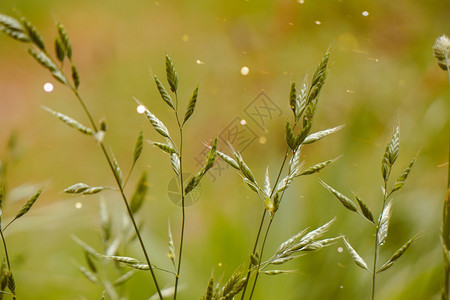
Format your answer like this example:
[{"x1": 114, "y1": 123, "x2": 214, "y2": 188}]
[{"x1": 0, "y1": 14, "x2": 163, "y2": 299}]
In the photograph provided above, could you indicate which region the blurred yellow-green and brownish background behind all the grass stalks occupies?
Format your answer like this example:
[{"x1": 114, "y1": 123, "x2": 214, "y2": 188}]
[{"x1": 0, "y1": 0, "x2": 450, "y2": 299}]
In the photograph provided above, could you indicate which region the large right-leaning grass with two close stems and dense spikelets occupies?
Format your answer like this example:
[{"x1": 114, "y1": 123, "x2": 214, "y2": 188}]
[{"x1": 213, "y1": 51, "x2": 342, "y2": 299}]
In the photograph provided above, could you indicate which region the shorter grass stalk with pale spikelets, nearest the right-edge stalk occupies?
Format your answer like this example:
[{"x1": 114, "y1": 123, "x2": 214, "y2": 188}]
[{"x1": 321, "y1": 127, "x2": 418, "y2": 300}]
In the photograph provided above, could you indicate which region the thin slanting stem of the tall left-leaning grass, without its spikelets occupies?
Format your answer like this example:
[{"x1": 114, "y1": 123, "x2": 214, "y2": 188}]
[{"x1": 67, "y1": 84, "x2": 163, "y2": 300}]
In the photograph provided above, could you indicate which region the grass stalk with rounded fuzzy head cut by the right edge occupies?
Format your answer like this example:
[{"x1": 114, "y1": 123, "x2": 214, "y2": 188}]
[{"x1": 433, "y1": 35, "x2": 450, "y2": 300}]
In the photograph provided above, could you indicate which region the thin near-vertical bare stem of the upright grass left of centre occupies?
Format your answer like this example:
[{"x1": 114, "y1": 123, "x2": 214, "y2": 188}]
[{"x1": 173, "y1": 93, "x2": 186, "y2": 300}]
